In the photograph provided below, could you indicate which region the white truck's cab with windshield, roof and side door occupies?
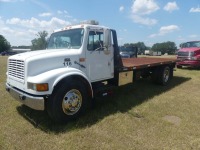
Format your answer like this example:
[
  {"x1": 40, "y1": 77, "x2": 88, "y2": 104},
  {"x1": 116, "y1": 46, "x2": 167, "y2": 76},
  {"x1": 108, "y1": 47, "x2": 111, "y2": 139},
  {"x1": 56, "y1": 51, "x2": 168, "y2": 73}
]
[{"x1": 47, "y1": 22, "x2": 114, "y2": 82}]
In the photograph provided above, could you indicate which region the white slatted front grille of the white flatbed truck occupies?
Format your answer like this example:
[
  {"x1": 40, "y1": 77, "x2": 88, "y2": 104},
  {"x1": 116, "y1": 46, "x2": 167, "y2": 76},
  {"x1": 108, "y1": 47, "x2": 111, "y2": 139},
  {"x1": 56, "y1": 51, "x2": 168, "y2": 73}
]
[{"x1": 8, "y1": 59, "x2": 24, "y2": 80}]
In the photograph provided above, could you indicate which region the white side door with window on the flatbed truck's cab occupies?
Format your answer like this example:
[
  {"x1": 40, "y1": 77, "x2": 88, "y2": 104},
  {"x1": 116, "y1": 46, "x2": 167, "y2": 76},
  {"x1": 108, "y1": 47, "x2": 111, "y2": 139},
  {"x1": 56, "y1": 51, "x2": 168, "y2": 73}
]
[{"x1": 86, "y1": 29, "x2": 114, "y2": 82}]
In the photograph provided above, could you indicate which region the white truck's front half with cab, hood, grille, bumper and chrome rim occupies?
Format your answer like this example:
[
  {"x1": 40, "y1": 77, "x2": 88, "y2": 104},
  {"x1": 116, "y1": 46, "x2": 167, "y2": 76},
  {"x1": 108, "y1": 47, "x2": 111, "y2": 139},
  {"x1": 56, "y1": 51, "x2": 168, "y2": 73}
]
[{"x1": 6, "y1": 21, "x2": 114, "y2": 120}]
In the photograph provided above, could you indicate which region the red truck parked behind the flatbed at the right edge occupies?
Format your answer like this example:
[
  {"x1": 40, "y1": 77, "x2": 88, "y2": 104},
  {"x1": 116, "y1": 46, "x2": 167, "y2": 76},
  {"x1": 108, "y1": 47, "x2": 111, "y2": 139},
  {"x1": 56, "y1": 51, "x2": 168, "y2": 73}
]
[{"x1": 176, "y1": 41, "x2": 200, "y2": 68}]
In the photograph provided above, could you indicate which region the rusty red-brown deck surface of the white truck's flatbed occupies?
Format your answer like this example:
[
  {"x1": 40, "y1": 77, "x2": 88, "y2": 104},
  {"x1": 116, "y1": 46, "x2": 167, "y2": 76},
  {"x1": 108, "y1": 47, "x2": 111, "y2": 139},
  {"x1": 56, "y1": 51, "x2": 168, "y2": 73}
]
[{"x1": 122, "y1": 57, "x2": 176, "y2": 70}]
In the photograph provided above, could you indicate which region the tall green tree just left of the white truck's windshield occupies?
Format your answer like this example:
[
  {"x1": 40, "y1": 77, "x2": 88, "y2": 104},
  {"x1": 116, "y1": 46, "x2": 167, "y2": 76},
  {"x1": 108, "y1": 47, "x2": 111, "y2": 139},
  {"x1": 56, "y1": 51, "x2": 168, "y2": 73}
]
[{"x1": 31, "y1": 31, "x2": 48, "y2": 50}]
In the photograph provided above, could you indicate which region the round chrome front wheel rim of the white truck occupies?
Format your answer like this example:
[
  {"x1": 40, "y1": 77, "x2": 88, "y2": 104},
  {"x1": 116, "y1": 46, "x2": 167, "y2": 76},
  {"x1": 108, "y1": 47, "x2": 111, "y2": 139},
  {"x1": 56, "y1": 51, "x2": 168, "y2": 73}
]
[{"x1": 62, "y1": 89, "x2": 82, "y2": 115}]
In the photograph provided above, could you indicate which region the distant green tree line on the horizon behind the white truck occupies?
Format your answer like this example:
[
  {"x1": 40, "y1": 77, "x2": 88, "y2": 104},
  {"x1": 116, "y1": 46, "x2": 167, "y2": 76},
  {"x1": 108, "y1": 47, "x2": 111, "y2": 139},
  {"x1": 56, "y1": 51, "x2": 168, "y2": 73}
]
[{"x1": 0, "y1": 31, "x2": 177, "y2": 54}]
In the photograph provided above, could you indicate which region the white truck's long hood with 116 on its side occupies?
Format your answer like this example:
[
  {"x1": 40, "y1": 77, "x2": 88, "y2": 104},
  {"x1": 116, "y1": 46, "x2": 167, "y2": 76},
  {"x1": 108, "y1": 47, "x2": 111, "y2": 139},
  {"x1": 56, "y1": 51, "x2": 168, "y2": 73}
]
[{"x1": 9, "y1": 49, "x2": 81, "y2": 76}]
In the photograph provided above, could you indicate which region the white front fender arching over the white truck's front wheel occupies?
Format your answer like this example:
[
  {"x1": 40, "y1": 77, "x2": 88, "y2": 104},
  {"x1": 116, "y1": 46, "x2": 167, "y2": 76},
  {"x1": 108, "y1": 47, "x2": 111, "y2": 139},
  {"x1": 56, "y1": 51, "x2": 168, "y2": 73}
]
[{"x1": 27, "y1": 68, "x2": 93, "y2": 97}]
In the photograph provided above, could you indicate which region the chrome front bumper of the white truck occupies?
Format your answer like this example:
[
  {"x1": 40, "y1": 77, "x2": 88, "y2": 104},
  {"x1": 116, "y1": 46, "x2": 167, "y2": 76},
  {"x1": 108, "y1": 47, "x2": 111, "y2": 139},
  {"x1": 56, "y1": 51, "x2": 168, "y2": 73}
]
[{"x1": 6, "y1": 84, "x2": 45, "y2": 110}]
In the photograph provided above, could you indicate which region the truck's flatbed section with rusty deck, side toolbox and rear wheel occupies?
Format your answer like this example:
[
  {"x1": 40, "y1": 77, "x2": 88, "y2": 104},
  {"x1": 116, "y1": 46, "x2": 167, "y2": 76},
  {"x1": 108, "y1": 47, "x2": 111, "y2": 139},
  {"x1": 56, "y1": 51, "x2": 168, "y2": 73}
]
[{"x1": 112, "y1": 57, "x2": 176, "y2": 86}]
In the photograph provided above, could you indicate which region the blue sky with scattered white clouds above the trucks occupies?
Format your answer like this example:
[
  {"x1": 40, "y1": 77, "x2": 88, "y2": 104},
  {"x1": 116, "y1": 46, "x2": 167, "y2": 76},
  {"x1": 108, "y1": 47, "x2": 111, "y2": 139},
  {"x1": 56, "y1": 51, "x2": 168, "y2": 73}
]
[{"x1": 0, "y1": 0, "x2": 200, "y2": 46}]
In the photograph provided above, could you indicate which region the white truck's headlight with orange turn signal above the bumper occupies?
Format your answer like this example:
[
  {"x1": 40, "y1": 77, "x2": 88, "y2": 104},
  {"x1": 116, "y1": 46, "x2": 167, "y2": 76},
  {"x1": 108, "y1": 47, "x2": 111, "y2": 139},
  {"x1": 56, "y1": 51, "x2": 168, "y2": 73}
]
[{"x1": 28, "y1": 83, "x2": 49, "y2": 92}]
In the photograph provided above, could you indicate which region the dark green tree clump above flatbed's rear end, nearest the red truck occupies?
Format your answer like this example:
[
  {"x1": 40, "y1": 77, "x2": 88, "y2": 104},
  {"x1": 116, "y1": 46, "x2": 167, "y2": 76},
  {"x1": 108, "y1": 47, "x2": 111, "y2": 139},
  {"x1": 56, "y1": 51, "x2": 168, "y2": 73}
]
[{"x1": 151, "y1": 41, "x2": 177, "y2": 54}]
